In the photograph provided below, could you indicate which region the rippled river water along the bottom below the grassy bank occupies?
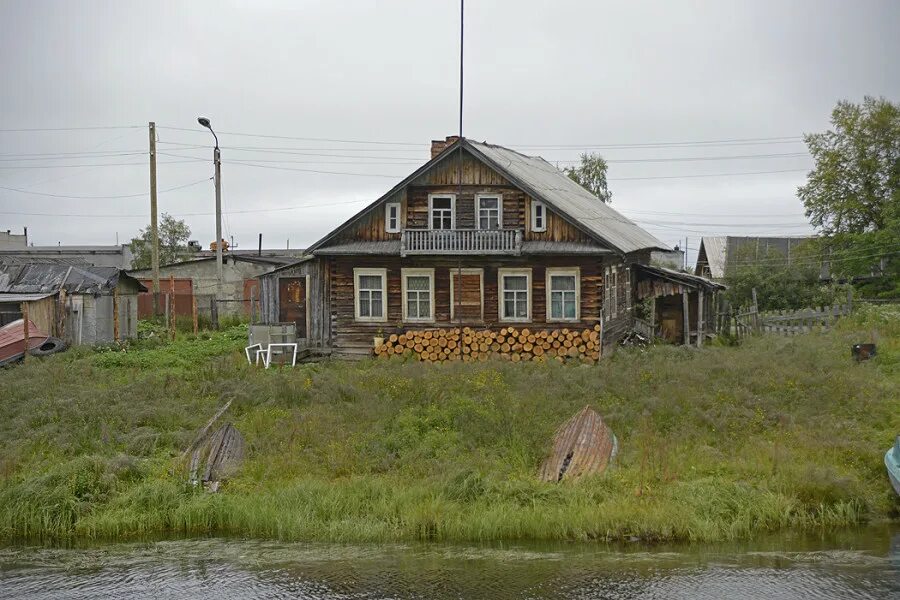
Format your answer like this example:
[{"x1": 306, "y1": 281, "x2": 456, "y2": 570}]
[{"x1": 0, "y1": 527, "x2": 900, "y2": 600}]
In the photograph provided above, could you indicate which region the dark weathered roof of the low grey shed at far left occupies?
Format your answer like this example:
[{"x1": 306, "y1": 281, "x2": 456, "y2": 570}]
[{"x1": 0, "y1": 264, "x2": 146, "y2": 295}]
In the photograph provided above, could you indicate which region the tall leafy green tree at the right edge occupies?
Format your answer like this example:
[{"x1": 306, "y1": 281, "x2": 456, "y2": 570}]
[{"x1": 797, "y1": 96, "x2": 900, "y2": 295}]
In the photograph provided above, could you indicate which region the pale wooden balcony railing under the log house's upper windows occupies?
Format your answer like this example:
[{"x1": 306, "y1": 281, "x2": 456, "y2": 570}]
[{"x1": 400, "y1": 229, "x2": 522, "y2": 256}]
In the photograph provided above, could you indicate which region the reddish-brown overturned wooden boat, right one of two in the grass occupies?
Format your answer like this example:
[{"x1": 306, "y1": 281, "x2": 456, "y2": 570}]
[{"x1": 540, "y1": 406, "x2": 618, "y2": 481}]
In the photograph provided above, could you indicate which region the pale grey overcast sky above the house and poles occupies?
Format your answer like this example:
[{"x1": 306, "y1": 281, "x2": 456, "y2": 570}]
[{"x1": 0, "y1": 0, "x2": 900, "y2": 264}]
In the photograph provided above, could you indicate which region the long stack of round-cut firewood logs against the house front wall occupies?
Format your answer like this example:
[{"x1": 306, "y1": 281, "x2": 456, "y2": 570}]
[{"x1": 375, "y1": 325, "x2": 600, "y2": 362}]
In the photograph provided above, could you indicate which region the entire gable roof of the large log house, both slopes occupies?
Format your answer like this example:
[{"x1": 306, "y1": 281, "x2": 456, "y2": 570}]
[{"x1": 308, "y1": 138, "x2": 668, "y2": 254}]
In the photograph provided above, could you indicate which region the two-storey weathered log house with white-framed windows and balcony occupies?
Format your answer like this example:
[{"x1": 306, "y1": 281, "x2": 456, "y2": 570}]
[{"x1": 260, "y1": 137, "x2": 708, "y2": 355}]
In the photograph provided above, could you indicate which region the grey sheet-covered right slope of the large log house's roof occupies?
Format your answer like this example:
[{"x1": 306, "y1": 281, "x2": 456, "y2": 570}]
[{"x1": 465, "y1": 140, "x2": 669, "y2": 254}]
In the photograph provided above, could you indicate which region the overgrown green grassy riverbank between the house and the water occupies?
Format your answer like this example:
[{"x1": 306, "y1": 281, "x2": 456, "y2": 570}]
[{"x1": 0, "y1": 309, "x2": 900, "y2": 541}]
